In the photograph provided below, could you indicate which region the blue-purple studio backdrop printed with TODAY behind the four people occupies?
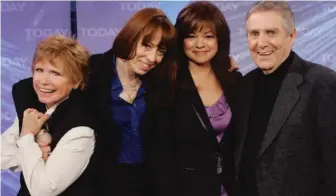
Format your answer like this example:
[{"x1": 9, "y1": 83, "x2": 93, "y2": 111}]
[{"x1": 1, "y1": 1, "x2": 336, "y2": 196}]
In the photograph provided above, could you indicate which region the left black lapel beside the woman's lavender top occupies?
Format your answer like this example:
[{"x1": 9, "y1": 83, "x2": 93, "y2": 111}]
[{"x1": 181, "y1": 69, "x2": 218, "y2": 145}]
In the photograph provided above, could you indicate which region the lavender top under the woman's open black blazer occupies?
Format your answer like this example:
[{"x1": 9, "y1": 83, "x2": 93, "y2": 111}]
[{"x1": 205, "y1": 95, "x2": 232, "y2": 196}]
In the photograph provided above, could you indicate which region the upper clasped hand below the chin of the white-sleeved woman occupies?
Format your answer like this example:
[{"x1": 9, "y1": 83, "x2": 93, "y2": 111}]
[{"x1": 21, "y1": 108, "x2": 49, "y2": 137}]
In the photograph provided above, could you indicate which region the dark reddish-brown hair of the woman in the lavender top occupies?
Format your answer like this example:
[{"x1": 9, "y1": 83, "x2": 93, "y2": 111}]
[{"x1": 175, "y1": 1, "x2": 235, "y2": 86}]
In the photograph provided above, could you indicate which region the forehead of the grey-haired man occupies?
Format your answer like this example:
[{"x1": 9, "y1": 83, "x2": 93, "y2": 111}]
[{"x1": 246, "y1": 11, "x2": 284, "y2": 30}]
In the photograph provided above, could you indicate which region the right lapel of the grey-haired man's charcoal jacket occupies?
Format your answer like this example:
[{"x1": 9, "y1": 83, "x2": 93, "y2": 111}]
[{"x1": 258, "y1": 54, "x2": 303, "y2": 158}]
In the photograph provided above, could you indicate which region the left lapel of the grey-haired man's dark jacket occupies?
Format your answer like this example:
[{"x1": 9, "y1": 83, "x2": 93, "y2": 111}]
[{"x1": 235, "y1": 69, "x2": 260, "y2": 171}]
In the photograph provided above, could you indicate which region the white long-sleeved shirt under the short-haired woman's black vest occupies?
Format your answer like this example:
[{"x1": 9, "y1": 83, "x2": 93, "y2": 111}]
[{"x1": 1, "y1": 106, "x2": 95, "y2": 196}]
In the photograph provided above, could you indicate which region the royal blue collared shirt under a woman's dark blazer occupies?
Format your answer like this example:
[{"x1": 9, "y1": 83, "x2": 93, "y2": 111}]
[{"x1": 111, "y1": 58, "x2": 145, "y2": 164}]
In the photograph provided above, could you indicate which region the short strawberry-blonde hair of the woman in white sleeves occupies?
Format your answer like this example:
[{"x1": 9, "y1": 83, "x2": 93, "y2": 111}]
[{"x1": 32, "y1": 35, "x2": 90, "y2": 89}]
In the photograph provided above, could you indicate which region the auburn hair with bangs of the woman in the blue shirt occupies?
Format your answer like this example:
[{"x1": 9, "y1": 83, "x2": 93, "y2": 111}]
[{"x1": 112, "y1": 8, "x2": 175, "y2": 60}]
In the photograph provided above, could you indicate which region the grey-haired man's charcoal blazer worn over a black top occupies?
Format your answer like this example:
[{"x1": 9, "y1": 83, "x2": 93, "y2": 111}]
[{"x1": 235, "y1": 54, "x2": 336, "y2": 196}]
